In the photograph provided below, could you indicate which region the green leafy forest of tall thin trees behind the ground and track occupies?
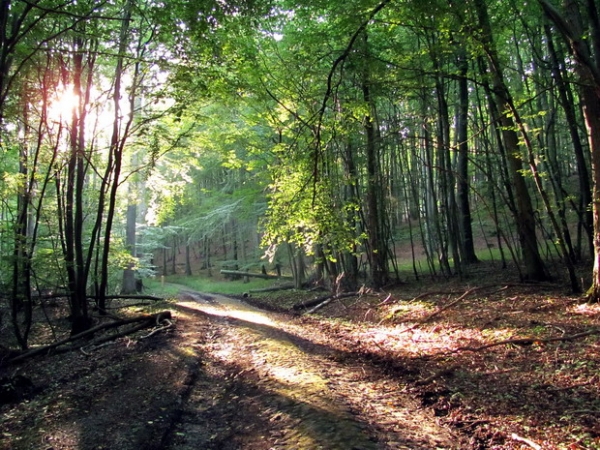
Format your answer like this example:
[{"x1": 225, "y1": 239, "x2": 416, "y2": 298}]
[{"x1": 0, "y1": 0, "x2": 600, "y2": 449}]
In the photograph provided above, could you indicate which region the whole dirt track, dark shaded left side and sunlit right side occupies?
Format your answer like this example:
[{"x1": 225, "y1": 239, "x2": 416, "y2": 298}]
[{"x1": 0, "y1": 292, "x2": 465, "y2": 450}]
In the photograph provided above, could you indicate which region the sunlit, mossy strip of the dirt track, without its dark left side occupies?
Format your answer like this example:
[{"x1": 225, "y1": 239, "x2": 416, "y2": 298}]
[{"x1": 173, "y1": 296, "x2": 458, "y2": 449}]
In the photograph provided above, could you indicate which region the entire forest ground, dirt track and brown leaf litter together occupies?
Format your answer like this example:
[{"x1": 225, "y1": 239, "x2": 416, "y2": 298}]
[{"x1": 0, "y1": 262, "x2": 600, "y2": 450}]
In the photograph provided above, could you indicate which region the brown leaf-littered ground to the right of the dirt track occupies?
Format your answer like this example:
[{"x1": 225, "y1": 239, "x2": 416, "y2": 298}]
[{"x1": 250, "y1": 284, "x2": 600, "y2": 450}]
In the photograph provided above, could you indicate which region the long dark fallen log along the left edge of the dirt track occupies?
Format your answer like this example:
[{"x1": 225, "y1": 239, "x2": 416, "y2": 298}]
[{"x1": 8, "y1": 311, "x2": 171, "y2": 363}]
